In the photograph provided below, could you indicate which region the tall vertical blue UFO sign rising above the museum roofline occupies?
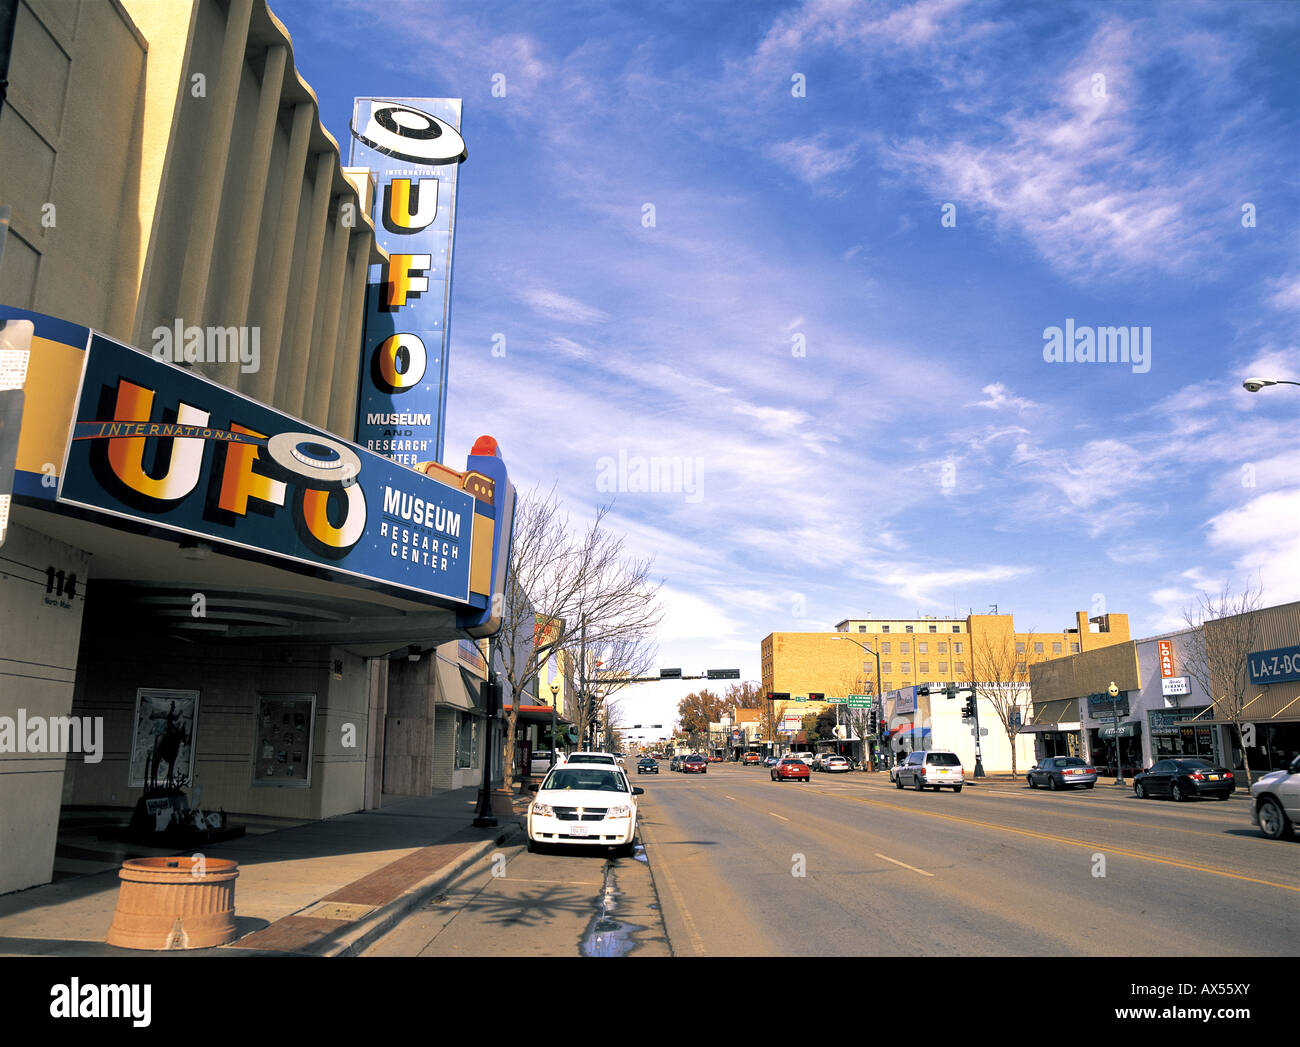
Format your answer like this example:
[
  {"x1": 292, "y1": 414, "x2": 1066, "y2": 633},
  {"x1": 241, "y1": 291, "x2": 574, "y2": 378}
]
[{"x1": 348, "y1": 98, "x2": 465, "y2": 466}]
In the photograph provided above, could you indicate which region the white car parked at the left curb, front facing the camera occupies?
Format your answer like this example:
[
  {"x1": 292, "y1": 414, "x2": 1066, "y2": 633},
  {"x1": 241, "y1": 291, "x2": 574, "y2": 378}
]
[{"x1": 528, "y1": 763, "x2": 645, "y2": 856}]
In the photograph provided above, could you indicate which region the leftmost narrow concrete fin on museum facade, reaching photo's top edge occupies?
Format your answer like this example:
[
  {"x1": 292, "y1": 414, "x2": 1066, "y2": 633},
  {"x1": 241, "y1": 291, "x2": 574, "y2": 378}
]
[{"x1": 176, "y1": 0, "x2": 252, "y2": 324}]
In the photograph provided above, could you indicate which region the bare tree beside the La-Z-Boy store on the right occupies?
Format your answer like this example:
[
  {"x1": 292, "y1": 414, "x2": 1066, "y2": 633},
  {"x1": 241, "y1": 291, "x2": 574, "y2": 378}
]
[{"x1": 1183, "y1": 581, "x2": 1264, "y2": 786}]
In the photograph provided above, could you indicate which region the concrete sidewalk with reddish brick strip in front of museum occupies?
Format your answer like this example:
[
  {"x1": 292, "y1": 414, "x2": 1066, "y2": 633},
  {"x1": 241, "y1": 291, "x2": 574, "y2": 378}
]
[{"x1": 0, "y1": 788, "x2": 528, "y2": 956}]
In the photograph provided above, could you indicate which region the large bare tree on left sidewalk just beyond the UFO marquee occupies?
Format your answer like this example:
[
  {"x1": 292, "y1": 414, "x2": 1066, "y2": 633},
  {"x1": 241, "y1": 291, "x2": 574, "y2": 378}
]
[{"x1": 498, "y1": 488, "x2": 663, "y2": 789}]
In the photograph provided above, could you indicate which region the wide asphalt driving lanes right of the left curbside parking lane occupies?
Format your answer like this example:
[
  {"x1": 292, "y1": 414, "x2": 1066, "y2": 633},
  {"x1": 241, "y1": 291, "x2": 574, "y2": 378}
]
[{"x1": 638, "y1": 765, "x2": 1300, "y2": 956}]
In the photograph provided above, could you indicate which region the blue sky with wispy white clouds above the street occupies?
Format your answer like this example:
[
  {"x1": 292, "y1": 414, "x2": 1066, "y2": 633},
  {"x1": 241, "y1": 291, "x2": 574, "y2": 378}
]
[{"x1": 272, "y1": 0, "x2": 1300, "y2": 722}]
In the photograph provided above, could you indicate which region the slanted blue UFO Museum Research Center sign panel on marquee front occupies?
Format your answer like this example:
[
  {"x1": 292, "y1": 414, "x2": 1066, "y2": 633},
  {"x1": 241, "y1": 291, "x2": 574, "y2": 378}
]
[{"x1": 59, "y1": 333, "x2": 475, "y2": 605}]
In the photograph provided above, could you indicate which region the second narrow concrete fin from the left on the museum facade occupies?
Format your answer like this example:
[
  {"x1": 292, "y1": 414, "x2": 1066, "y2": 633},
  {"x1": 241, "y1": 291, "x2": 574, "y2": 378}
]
[{"x1": 213, "y1": 44, "x2": 289, "y2": 389}]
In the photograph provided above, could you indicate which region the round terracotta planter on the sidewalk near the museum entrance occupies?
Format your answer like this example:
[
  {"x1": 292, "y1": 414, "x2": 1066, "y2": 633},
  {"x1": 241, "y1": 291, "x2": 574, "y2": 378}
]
[{"x1": 107, "y1": 857, "x2": 239, "y2": 951}]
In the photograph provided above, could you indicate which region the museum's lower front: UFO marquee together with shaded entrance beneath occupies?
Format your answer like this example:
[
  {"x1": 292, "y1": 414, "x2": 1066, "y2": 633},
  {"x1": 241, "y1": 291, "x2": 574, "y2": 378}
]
[{"x1": 0, "y1": 307, "x2": 515, "y2": 891}]
